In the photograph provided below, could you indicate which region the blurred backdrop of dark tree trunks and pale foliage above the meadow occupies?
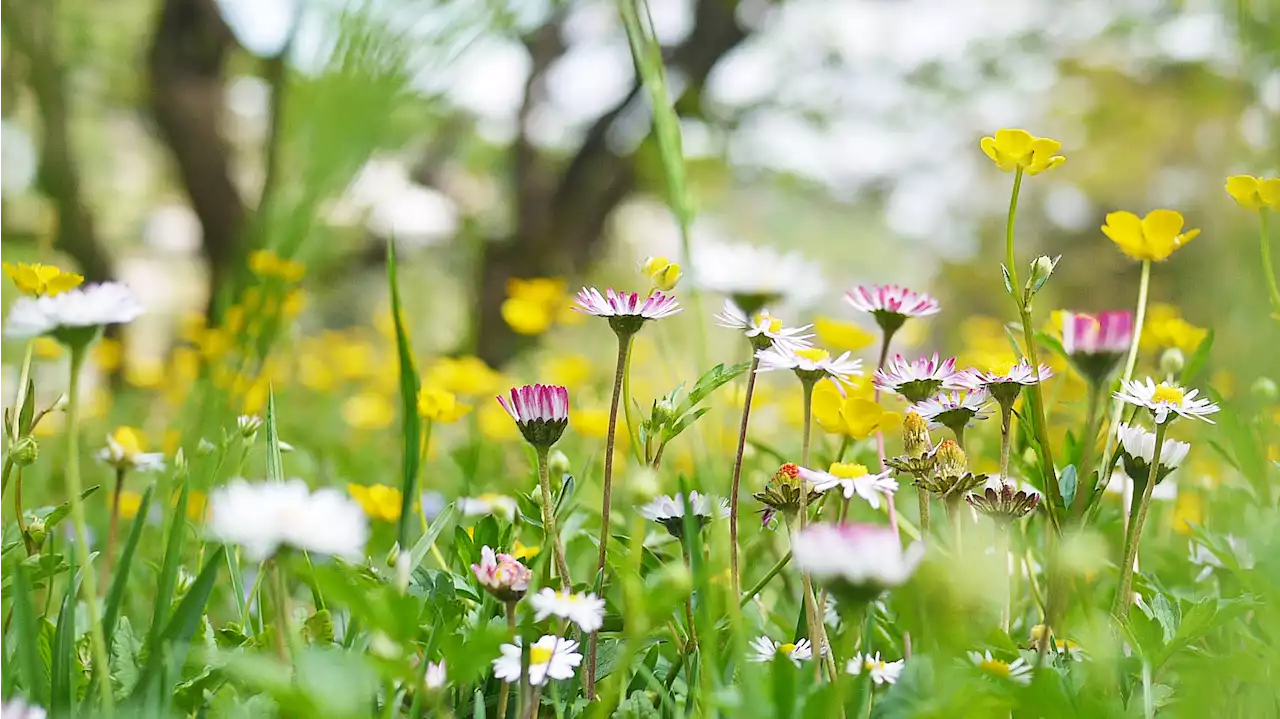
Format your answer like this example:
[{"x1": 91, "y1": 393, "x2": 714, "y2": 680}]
[{"x1": 0, "y1": 0, "x2": 1280, "y2": 389}]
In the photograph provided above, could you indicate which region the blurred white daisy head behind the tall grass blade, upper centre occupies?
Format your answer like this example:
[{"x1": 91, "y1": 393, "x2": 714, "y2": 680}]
[{"x1": 692, "y1": 243, "x2": 823, "y2": 315}]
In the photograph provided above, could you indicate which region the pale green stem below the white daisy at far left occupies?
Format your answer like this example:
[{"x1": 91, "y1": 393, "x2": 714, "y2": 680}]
[{"x1": 65, "y1": 344, "x2": 115, "y2": 718}]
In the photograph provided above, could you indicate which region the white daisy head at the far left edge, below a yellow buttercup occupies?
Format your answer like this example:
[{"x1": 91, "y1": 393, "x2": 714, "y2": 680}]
[{"x1": 4, "y1": 283, "x2": 142, "y2": 347}]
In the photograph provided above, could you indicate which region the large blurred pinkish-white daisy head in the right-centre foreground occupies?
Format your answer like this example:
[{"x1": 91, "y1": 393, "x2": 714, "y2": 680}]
[{"x1": 791, "y1": 523, "x2": 924, "y2": 603}]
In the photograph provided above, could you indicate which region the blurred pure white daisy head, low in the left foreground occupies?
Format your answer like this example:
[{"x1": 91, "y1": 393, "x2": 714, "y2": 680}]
[{"x1": 209, "y1": 480, "x2": 369, "y2": 562}]
